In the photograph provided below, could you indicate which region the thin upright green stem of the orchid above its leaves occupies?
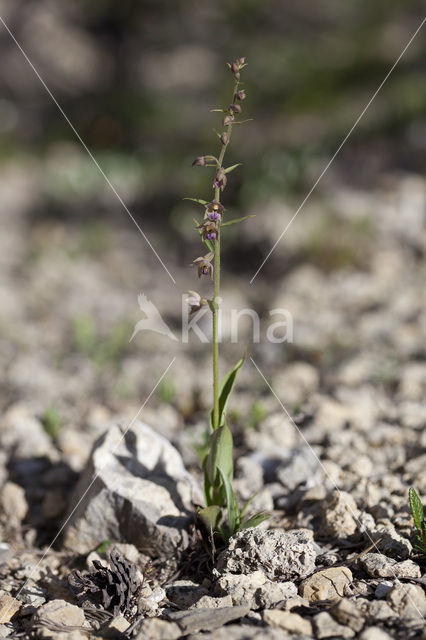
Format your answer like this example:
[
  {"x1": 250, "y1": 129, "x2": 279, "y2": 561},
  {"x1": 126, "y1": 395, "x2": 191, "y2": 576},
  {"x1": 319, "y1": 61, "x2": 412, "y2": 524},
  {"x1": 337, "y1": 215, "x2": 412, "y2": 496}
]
[{"x1": 212, "y1": 80, "x2": 239, "y2": 429}]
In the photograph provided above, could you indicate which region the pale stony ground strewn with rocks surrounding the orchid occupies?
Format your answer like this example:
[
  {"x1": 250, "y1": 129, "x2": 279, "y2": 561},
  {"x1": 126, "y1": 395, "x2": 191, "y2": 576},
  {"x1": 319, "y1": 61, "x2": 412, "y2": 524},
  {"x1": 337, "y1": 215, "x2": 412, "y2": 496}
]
[{"x1": 0, "y1": 165, "x2": 426, "y2": 640}]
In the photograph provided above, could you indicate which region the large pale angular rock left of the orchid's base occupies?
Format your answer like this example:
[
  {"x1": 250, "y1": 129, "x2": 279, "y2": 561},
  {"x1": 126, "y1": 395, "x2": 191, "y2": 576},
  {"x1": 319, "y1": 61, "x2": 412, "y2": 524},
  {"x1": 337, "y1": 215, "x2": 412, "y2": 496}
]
[{"x1": 64, "y1": 422, "x2": 196, "y2": 556}]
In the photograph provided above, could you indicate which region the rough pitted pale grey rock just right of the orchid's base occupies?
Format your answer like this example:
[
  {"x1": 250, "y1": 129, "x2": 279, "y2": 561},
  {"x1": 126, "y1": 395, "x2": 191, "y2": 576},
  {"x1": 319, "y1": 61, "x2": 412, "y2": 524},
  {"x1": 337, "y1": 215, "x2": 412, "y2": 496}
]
[{"x1": 217, "y1": 528, "x2": 316, "y2": 580}]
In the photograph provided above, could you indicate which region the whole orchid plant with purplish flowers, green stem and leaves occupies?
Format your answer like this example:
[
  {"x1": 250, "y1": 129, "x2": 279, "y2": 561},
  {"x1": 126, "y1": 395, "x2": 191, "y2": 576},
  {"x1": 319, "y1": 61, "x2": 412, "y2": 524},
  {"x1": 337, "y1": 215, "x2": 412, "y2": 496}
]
[{"x1": 186, "y1": 58, "x2": 268, "y2": 543}]
